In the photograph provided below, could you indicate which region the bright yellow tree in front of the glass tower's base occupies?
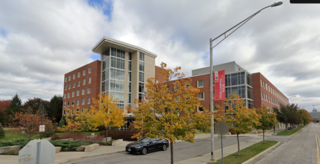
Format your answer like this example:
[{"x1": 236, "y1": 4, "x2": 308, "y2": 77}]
[{"x1": 89, "y1": 93, "x2": 125, "y2": 137}]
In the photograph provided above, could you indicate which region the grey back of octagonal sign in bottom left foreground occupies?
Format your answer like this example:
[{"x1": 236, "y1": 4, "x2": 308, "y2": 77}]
[{"x1": 19, "y1": 140, "x2": 56, "y2": 164}]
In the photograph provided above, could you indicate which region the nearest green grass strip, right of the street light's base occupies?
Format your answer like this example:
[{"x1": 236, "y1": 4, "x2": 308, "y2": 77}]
[{"x1": 208, "y1": 141, "x2": 278, "y2": 164}]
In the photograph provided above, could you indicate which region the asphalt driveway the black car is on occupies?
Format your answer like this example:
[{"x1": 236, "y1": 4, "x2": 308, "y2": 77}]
[{"x1": 68, "y1": 136, "x2": 254, "y2": 164}]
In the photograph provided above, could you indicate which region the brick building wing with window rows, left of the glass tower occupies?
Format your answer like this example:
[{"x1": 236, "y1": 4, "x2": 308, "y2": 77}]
[{"x1": 63, "y1": 60, "x2": 101, "y2": 114}]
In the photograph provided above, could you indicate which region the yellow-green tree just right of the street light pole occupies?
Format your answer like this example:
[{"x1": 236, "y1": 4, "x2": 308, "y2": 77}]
[{"x1": 225, "y1": 93, "x2": 260, "y2": 156}]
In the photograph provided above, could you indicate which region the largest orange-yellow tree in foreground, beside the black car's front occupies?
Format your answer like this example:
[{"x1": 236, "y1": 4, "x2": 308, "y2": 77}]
[{"x1": 133, "y1": 63, "x2": 211, "y2": 163}]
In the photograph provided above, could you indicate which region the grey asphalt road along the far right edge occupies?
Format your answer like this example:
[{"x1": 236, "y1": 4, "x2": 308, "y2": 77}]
[{"x1": 256, "y1": 123, "x2": 320, "y2": 164}]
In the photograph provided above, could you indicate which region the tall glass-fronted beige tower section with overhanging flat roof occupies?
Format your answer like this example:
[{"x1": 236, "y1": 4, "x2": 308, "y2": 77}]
[{"x1": 92, "y1": 37, "x2": 157, "y2": 113}]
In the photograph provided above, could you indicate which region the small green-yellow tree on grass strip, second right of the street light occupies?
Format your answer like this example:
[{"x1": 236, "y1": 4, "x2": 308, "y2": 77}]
[{"x1": 255, "y1": 106, "x2": 277, "y2": 143}]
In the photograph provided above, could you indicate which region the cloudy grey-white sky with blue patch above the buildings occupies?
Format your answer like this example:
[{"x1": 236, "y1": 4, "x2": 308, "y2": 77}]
[{"x1": 0, "y1": 0, "x2": 320, "y2": 111}]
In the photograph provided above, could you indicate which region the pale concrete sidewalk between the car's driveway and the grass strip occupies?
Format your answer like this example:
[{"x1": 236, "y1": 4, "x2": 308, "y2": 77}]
[{"x1": 175, "y1": 139, "x2": 262, "y2": 164}]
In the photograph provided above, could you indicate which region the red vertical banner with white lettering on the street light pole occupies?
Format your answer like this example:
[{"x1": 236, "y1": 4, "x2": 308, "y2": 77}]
[{"x1": 213, "y1": 70, "x2": 226, "y2": 100}]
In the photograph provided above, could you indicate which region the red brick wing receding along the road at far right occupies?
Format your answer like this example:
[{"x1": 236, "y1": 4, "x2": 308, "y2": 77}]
[{"x1": 252, "y1": 72, "x2": 289, "y2": 110}]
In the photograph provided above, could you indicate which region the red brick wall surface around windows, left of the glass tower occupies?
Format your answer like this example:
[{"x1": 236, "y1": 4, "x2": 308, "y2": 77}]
[{"x1": 63, "y1": 60, "x2": 101, "y2": 114}]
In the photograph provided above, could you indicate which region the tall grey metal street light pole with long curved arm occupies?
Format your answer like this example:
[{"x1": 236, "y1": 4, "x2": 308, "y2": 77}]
[{"x1": 209, "y1": 1, "x2": 282, "y2": 161}]
